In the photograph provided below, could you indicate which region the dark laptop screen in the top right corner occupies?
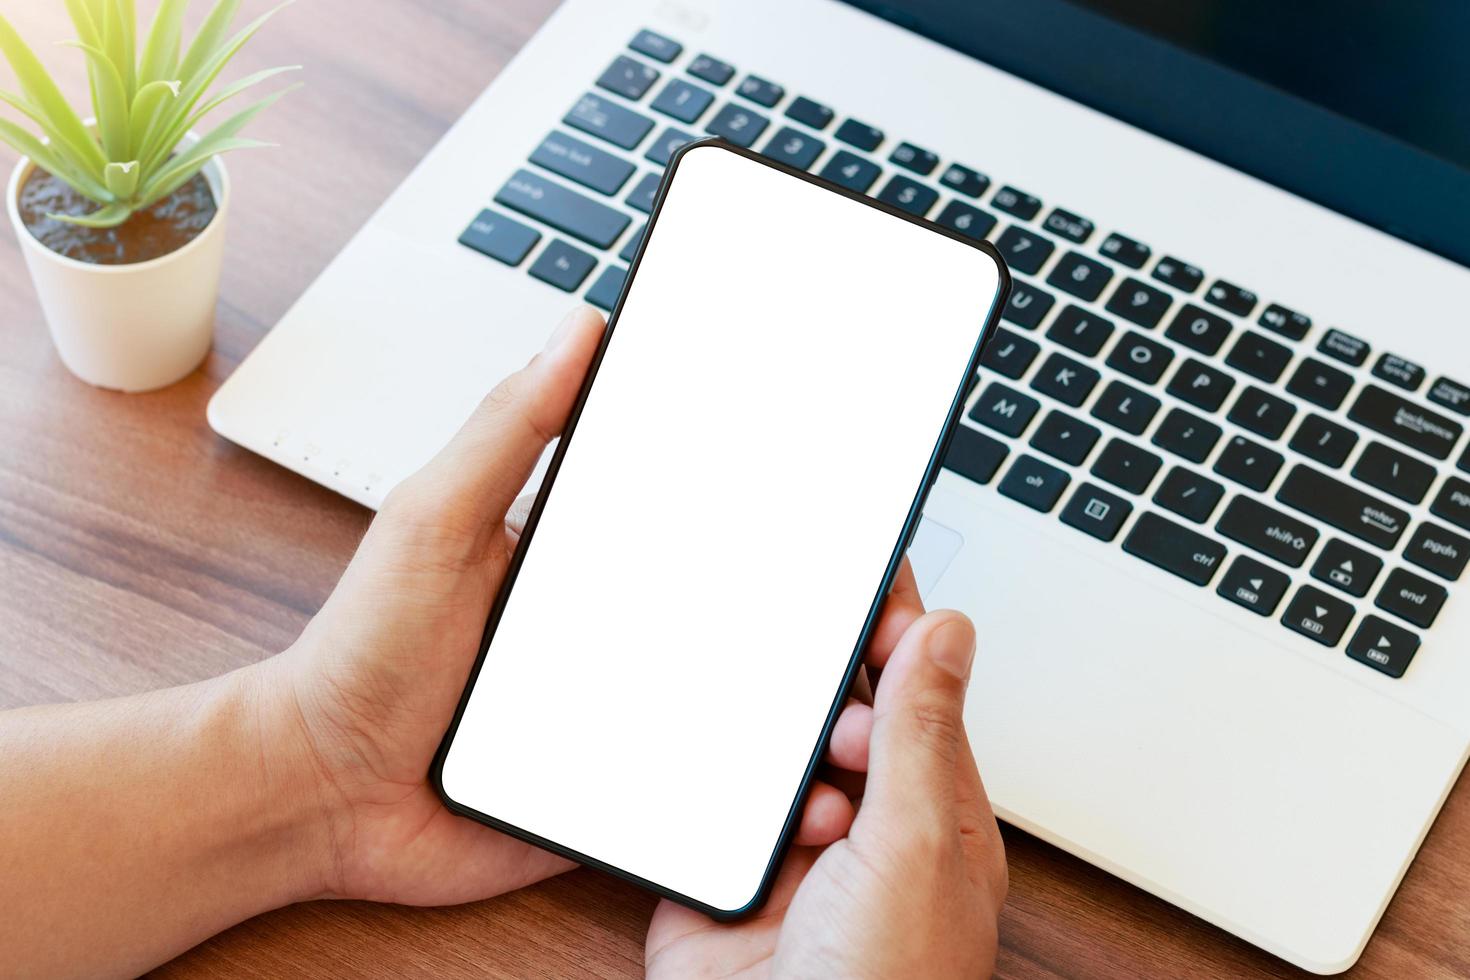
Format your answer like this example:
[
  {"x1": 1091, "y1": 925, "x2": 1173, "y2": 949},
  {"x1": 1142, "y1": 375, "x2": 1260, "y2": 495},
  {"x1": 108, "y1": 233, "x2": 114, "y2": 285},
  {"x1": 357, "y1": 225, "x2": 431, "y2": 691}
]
[{"x1": 850, "y1": 0, "x2": 1470, "y2": 264}]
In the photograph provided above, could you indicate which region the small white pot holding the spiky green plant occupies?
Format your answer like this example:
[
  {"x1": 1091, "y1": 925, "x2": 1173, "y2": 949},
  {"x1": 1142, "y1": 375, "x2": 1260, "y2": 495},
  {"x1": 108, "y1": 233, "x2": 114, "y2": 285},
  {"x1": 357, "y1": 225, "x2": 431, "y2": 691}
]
[{"x1": 6, "y1": 142, "x2": 229, "y2": 391}]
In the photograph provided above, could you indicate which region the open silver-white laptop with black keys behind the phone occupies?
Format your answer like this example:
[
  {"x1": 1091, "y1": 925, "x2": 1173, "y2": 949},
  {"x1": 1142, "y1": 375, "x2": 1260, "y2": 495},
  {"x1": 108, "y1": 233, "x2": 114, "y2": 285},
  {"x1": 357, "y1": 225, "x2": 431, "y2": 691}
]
[{"x1": 209, "y1": 0, "x2": 1470, "y2": 973}]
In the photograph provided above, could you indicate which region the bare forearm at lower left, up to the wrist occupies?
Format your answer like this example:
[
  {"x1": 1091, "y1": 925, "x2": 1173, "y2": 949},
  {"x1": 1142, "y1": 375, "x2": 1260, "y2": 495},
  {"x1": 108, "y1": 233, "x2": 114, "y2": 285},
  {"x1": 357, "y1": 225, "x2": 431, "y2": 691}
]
[{"x1": 0, "y1": 670, "x2": 331, "y2": 977}]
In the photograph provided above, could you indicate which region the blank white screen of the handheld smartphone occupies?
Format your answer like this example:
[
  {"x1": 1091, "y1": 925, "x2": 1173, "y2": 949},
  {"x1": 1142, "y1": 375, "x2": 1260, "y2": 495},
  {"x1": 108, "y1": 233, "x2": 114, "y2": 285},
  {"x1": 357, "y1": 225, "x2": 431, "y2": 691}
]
[{"x1": 442, "y1": 145, "x2": 1000, "y2": 911}]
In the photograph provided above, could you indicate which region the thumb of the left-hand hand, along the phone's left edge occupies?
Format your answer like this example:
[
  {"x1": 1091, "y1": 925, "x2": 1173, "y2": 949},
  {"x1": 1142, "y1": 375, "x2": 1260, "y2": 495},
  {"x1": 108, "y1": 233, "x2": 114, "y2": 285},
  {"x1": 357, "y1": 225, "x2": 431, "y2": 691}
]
[{"x1": 408, "y1": 306, "x2": 604, "y2": 523}]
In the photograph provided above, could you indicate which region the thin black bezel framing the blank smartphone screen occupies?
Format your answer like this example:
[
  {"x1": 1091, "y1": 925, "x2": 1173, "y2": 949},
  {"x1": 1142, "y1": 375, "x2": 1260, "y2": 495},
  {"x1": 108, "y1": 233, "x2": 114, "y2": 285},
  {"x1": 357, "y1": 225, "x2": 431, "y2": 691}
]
[{"x1": 428, "y1": 138, "x2": 1011, "y2": 921}]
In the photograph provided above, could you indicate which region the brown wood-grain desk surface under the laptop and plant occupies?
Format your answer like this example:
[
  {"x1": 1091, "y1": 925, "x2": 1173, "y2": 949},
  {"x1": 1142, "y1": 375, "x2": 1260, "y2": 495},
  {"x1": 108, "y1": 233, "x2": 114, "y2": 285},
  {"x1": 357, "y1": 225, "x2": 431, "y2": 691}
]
[{"x1": 0, "y1": 0, "x2": 1470, "y2": 980}]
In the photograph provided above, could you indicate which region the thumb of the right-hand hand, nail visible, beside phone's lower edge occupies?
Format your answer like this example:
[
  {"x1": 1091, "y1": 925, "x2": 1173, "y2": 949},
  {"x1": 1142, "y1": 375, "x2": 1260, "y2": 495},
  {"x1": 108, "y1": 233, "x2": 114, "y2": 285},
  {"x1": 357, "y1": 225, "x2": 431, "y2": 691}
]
[{"x1": 863, "y1": 611, "x2": 975, "y2": 821}]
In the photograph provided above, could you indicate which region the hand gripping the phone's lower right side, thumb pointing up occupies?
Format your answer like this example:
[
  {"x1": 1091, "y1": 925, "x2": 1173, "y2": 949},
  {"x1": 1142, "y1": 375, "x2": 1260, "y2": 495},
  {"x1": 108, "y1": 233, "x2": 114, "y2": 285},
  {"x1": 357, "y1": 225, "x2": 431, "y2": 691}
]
[{"x1": 644, "y1": 587, "x2": 1007, "y2": 979}]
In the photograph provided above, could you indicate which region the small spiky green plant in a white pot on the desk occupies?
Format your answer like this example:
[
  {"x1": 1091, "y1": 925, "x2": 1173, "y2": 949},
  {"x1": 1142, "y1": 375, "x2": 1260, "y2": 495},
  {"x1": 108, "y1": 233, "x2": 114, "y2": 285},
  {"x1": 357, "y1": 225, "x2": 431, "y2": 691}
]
[{"x1": 0, "y1": 0, "x2": 291, "y2": 391}]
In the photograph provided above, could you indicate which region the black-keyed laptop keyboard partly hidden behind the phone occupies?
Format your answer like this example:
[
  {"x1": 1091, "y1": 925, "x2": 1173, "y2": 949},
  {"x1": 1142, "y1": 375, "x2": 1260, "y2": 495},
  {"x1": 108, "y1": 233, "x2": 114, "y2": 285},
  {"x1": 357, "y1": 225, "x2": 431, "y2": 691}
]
[{"x1": 460, "y1": 31, "x2": 1470, "y2": 677}]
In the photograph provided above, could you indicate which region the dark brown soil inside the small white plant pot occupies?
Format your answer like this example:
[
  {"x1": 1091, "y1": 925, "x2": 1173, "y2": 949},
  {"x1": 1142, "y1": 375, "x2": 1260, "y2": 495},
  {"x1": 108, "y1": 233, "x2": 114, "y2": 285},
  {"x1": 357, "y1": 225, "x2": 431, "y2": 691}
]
[{"x1": 18, "y1": 167, "x2": 218, "y2": 266}]
